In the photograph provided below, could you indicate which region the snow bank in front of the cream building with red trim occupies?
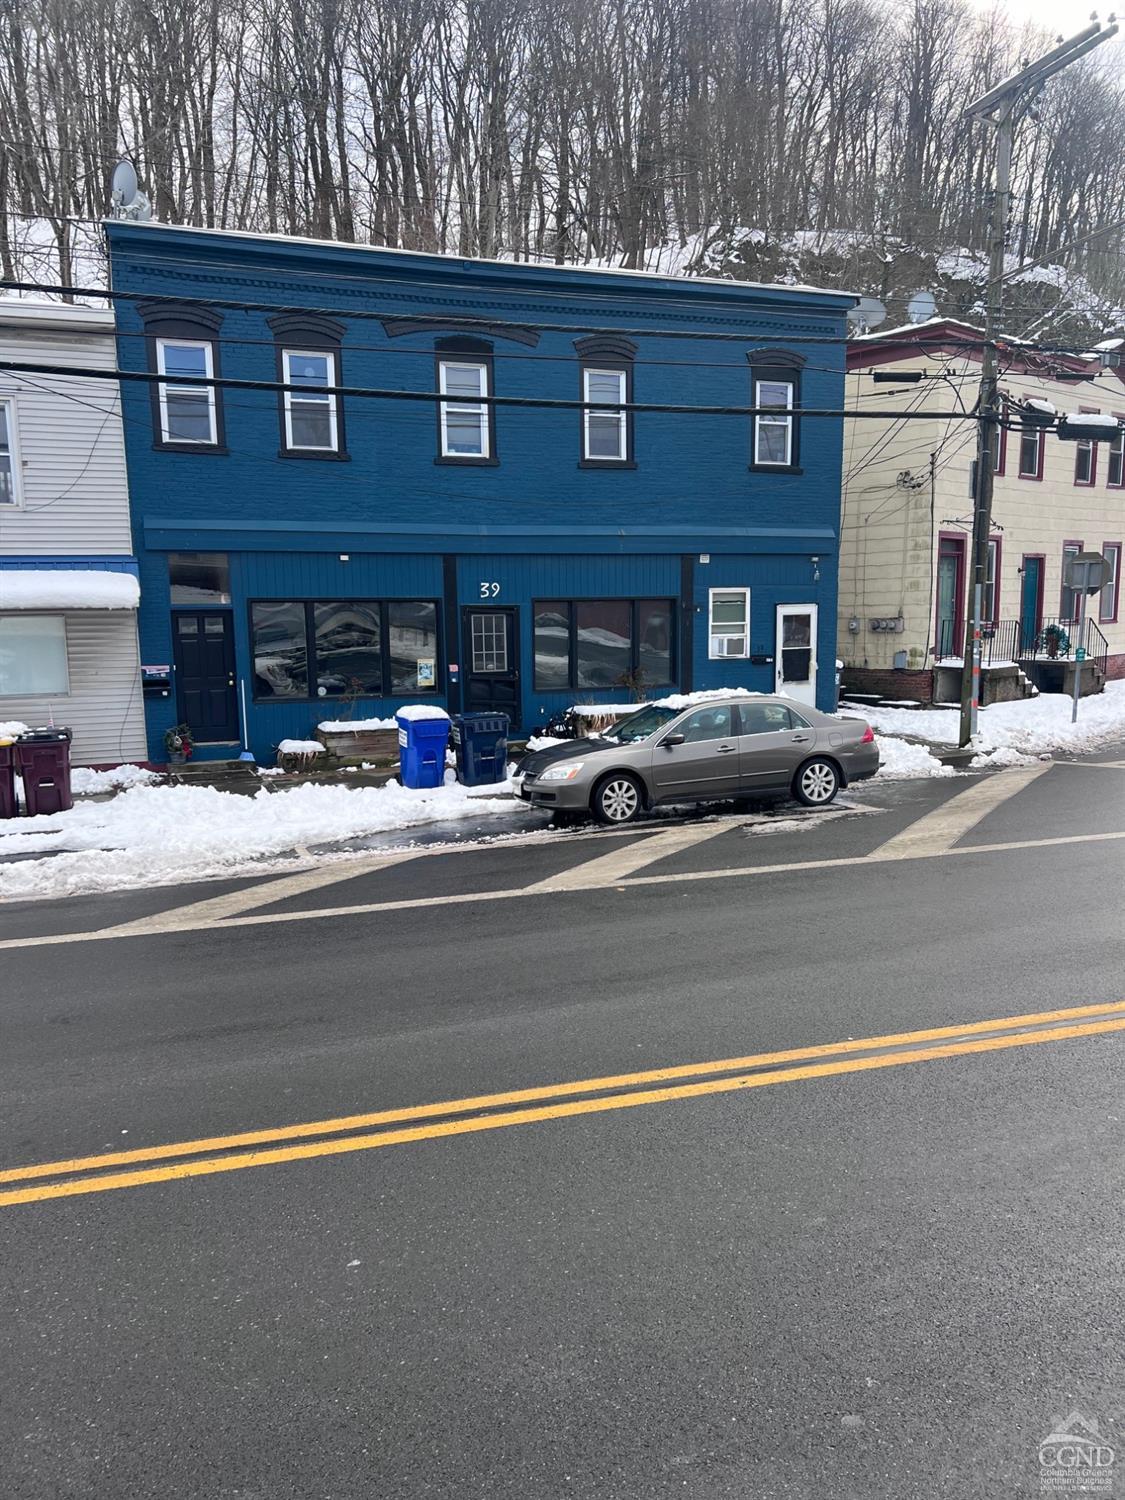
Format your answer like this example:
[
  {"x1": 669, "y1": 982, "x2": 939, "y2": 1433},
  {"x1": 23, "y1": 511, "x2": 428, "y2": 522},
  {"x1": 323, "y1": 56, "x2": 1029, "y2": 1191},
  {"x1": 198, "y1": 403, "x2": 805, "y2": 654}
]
[{"x1": 842, "y1": 681, "x2": 1125, "y2": 765}]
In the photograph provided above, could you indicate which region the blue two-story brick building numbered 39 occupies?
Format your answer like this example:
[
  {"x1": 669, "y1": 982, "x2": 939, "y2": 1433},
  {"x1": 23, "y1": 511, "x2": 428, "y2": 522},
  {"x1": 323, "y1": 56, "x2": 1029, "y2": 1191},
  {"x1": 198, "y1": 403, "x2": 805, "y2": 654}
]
[{"x1": 108, "y1": 224, "x2": 854, "y2": 761}]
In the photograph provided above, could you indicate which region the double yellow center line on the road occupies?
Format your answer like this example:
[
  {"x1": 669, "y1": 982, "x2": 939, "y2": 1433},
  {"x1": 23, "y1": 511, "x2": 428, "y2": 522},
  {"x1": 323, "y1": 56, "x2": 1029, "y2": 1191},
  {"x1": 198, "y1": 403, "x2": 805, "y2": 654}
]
[{"x1": 0, "y1": 1001, "x2": 1125, "y2": 1206}]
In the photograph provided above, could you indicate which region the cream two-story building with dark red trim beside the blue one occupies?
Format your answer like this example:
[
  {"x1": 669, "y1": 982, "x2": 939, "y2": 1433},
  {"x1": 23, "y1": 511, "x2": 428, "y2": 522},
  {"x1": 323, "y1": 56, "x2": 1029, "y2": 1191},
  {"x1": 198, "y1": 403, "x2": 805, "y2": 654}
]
[{"x1": 839, "y1": 318, "x2": 1125, "y2": 702}]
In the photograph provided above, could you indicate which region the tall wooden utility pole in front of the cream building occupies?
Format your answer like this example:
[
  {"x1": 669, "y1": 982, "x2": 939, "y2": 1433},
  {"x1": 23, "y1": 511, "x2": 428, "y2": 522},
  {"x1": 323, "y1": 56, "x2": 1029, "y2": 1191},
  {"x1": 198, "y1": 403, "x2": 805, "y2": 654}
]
[{"x1": 960, "y1": 17, "x2": 1118, "y2": 746}]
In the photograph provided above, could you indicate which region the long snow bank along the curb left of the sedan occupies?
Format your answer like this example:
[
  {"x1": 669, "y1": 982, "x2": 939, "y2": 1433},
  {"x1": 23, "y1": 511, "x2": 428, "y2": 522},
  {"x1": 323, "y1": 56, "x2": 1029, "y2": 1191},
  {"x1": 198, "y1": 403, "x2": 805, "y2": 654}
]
[{"x1": 0, "y1": 782, "x2": 521, "y2": 900}]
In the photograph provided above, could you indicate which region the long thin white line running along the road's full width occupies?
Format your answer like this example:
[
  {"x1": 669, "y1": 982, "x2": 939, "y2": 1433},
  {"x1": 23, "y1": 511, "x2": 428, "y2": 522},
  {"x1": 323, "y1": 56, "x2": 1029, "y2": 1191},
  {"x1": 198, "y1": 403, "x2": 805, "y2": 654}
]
[{"x1": 0, "y1": 828, "x2": 1125, "y2": 951}]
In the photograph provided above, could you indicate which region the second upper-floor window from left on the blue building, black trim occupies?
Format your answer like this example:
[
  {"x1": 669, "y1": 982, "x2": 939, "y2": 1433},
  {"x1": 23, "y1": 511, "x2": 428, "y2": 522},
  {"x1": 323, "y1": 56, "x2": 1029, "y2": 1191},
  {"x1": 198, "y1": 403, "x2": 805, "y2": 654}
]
[{"x1": 269, "y1": 312, "x2": 347, "y2": 459}]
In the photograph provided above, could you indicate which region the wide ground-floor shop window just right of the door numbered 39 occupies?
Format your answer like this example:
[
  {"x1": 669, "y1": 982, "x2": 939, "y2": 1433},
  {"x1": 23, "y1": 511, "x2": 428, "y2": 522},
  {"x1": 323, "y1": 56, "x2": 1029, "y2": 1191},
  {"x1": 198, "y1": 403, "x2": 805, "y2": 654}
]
[{"x1": 533, "y1": 599, "x2": 675, "y2": 692}]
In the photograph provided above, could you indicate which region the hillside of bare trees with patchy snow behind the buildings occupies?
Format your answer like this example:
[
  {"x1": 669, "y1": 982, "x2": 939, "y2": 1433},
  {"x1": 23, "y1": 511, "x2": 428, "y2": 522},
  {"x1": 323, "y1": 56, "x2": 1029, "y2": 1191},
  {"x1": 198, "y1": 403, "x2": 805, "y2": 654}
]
[{"x1": 0, "y1": 0, "x2": 1125, "y2": 332}]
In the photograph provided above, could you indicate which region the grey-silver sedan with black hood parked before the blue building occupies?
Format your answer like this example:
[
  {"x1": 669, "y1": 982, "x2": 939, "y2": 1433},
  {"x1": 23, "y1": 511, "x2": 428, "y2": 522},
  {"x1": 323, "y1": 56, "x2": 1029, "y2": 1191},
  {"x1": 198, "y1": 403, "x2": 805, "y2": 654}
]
[{"x1": 515, "y1": 695, "x2": 879, "y2": 825}]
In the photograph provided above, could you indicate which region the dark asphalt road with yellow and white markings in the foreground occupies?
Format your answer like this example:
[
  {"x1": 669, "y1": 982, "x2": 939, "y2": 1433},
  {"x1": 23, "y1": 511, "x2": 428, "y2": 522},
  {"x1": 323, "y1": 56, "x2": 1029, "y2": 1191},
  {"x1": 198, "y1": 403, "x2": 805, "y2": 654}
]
[{"x1": 0, "y1": 750, "x2": 1125, "y2": 1500}]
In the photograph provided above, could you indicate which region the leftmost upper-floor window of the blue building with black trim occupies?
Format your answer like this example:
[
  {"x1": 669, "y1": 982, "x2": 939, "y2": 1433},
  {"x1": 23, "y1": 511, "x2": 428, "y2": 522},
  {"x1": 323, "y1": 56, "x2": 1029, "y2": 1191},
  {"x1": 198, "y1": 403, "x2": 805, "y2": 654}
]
[{"x1": 137, "y1": 302, "x2": 225, "y2": 453}]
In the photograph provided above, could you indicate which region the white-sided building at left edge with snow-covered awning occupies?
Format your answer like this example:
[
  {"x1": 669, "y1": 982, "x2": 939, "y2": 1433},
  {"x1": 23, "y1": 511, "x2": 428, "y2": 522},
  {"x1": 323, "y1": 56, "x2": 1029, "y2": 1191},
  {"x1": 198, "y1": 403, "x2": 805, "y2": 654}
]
[{"x1": 0, "y1": 300, "x2": 146, "y2": 765}]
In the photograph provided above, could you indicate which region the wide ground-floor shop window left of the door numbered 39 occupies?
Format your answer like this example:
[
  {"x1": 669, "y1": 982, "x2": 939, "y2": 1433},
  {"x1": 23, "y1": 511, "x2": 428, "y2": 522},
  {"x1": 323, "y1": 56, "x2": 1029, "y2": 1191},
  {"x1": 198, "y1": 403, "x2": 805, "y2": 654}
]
[{"x1": 251, "y1": 599, "x2": 438, "y2": 701}]
